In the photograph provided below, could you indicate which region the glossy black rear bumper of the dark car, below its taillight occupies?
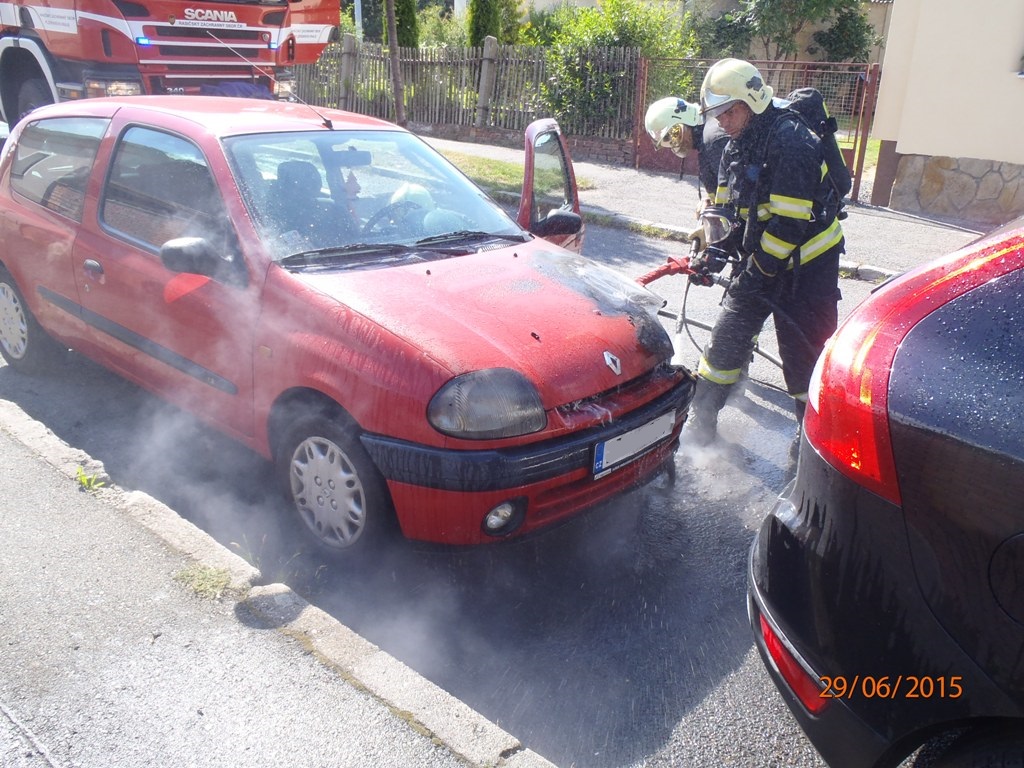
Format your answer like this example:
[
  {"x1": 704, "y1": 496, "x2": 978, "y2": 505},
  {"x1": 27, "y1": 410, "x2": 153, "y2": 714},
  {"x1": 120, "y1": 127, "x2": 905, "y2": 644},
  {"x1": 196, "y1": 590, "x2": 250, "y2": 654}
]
[{"x1": 749, "y1": 440, "x2": 1014, "y2": 768}]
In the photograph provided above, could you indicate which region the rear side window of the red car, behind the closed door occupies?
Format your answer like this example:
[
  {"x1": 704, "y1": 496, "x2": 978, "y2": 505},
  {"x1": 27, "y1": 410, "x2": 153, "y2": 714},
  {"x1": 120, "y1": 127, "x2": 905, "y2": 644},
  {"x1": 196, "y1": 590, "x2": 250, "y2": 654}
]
[{"x1": 10, "y1": 118, "x2": 110, "y2": 221}]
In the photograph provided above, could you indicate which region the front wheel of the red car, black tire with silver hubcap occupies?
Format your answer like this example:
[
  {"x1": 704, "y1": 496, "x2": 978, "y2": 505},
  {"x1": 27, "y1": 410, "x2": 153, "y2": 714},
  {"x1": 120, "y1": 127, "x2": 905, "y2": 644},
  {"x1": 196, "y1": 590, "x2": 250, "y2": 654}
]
[{"x1": 275, "y1": 409, "x2": 395, "y2": 553}]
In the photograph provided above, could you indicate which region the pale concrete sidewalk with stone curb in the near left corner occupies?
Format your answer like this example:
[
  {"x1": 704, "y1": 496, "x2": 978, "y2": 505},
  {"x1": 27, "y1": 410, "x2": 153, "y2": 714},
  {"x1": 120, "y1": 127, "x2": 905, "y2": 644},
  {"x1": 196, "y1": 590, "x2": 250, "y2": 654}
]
[{"x1": 0, "y1": 400, "x2": 551, "y2": 768}]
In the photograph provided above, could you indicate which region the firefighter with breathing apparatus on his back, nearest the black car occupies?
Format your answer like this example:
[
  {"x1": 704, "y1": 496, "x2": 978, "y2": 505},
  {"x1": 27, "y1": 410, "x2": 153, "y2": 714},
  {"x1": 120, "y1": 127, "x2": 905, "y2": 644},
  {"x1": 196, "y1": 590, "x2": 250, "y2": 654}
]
[{"x1": 687, "y1": 58, "x2": 845, "y2": 462}]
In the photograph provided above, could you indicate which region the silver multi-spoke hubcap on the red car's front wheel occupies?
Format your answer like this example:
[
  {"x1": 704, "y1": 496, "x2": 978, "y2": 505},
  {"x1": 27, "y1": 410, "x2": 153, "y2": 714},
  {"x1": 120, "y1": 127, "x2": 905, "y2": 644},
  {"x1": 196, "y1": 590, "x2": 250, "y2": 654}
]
[{"x1": 290, "y1": 437, "x2": 367, "y2": 549}]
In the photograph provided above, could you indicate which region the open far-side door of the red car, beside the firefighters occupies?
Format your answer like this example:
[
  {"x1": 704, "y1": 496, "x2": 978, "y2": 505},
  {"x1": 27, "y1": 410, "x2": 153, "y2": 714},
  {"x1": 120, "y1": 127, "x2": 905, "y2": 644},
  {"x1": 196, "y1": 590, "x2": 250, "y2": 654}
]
[{"x1": 516, "y1": 118, "x2": 584, "y2": 253}]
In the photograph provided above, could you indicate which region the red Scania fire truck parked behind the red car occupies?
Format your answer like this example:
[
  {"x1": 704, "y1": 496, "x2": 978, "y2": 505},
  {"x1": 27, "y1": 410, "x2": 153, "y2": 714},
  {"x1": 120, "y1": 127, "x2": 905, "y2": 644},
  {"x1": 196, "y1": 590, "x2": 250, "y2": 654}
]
[{"x1": 0, "y1": 0, "x2": 339, "y2": 125}]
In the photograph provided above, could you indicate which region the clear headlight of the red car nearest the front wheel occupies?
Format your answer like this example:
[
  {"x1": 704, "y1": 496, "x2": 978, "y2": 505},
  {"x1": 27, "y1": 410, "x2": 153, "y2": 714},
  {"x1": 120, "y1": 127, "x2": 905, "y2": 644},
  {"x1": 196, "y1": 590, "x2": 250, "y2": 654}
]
[{"x1": 427, "y1": 368, "x2": 548, "y2": 440}]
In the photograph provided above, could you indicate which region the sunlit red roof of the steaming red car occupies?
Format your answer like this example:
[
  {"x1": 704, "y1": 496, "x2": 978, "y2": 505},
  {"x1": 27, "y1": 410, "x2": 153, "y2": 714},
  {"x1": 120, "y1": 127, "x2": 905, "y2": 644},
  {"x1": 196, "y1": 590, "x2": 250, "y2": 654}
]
[{"x1": 24, "y1": 96, "x2": 403, "y2": 136}]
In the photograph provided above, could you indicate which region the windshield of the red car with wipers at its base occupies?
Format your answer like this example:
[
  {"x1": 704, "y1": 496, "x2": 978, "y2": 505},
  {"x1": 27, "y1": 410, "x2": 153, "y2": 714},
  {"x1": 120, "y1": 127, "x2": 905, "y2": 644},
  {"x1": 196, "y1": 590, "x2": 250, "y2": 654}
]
[{"x1": 224, "y1": 131, "x2": 523, "y2": 263}]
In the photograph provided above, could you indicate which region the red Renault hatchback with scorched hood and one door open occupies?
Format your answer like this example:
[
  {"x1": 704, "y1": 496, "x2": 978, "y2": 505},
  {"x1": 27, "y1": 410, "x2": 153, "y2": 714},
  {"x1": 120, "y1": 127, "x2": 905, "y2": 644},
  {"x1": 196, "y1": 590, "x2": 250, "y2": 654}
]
[{"x1": 0, "y1": 96, "x2": 693, "y2": 549}]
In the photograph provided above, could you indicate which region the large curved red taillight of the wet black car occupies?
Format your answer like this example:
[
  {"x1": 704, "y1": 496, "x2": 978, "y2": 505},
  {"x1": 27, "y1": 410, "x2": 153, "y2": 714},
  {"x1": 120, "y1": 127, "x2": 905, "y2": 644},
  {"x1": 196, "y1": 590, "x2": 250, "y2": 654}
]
[{"x1": 804, "y1": 232, "x2": 1024, "y2": 512}]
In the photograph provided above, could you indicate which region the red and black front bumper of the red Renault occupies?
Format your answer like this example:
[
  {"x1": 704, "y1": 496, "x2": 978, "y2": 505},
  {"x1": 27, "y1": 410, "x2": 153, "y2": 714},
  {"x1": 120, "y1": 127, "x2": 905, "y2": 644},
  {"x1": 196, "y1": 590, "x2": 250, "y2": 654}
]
[{"x1": 361, "y1": 377, "x2": 693, "y2": 545}]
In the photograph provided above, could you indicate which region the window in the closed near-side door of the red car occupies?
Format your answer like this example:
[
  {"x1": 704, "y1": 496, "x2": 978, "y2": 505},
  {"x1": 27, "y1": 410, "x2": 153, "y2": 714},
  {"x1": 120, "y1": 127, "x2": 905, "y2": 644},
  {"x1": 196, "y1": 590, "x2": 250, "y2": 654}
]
[{"x1": 99, "y1": 126, "x2": 237, "y2": 256}]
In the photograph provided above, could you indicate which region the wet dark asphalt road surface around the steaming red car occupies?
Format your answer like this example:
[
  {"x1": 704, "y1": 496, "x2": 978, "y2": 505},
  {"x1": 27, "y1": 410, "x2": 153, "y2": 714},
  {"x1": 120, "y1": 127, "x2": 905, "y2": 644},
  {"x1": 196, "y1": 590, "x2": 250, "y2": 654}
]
[{"x1": 0, "y1": 219, "x2": 884, "y2": 768}]
